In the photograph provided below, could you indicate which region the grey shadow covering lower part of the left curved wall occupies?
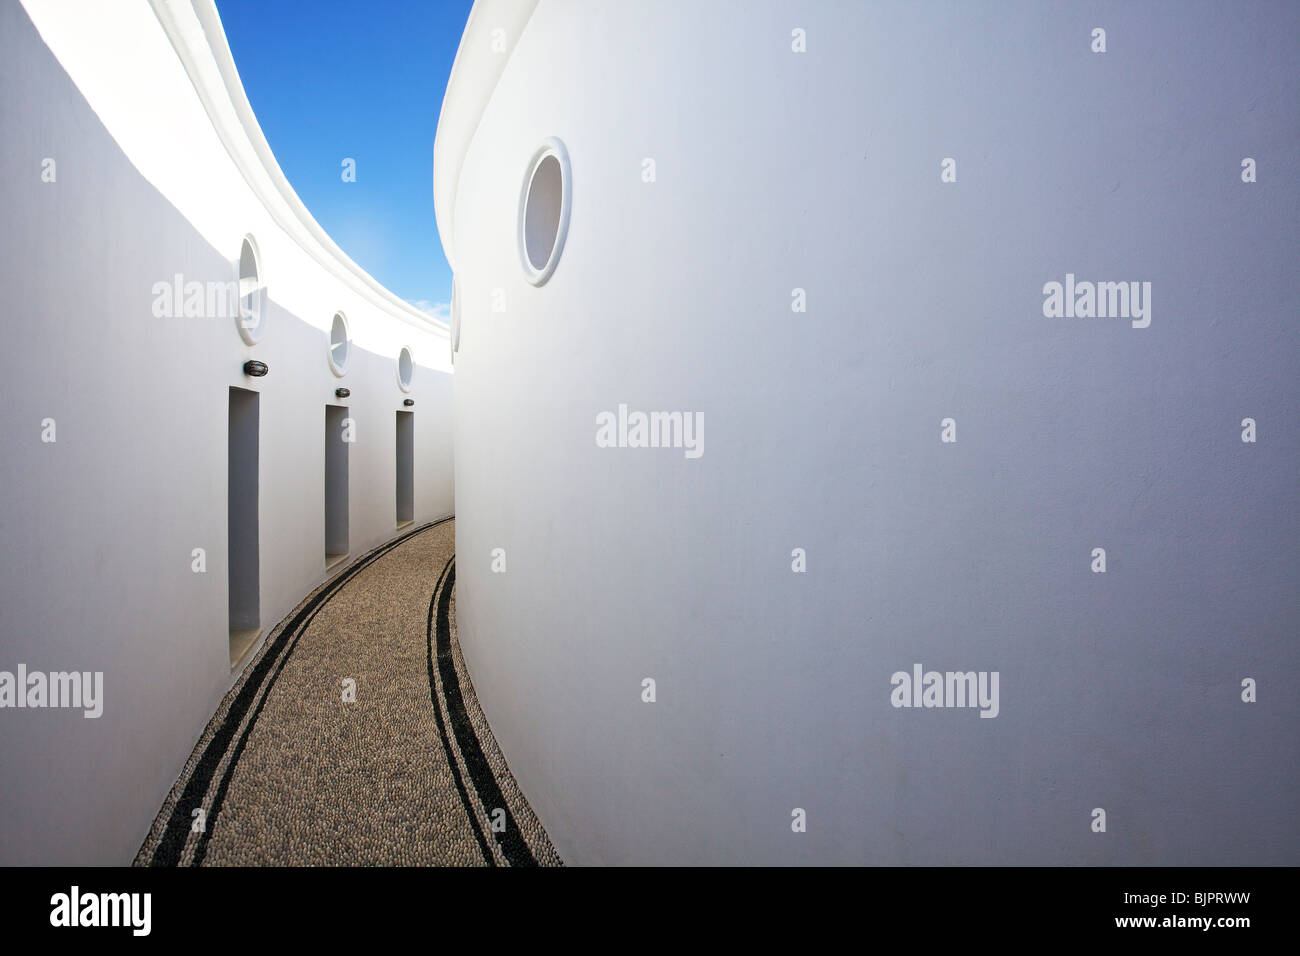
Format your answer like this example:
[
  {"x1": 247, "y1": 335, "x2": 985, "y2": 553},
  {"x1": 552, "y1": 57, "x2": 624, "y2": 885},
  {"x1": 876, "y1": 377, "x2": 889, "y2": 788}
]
[{"x1": 0, "y1": 4, "x2": 452, "y2": 865}]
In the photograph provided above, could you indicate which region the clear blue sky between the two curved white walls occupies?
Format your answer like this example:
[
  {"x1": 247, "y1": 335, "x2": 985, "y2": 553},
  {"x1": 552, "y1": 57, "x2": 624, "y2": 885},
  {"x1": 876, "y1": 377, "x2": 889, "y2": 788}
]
[{"x1": 217, "y1": 0, "x2": 473, "y2": 321}]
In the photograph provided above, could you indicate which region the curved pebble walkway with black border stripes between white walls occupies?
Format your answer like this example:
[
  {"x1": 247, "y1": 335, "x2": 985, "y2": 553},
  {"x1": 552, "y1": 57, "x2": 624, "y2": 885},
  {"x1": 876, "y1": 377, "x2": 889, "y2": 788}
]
[{"x1": 135, "y1": 519, "x2": 562, "y2": 866}]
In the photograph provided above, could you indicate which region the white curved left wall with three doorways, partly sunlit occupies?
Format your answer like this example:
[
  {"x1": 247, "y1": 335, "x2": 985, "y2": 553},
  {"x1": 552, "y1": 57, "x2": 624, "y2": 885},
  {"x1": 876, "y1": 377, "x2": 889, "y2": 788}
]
[{"x1": 0, "y1": 0, "x2": 452, "y2": 864}]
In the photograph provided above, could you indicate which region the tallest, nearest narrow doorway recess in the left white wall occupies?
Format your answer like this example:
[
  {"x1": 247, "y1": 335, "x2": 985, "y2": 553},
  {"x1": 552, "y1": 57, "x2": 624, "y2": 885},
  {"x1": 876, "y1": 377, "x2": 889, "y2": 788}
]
[{"x1": 226, "y1": 388, "x2": 261, "y2": 669}]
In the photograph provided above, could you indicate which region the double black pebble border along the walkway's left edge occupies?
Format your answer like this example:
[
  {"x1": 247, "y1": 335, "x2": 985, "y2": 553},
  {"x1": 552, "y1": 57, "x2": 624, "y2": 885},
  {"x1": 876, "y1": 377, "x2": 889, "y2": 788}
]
[{"x1": 150, "y1": 515, "x2": 454, "y2": 866}]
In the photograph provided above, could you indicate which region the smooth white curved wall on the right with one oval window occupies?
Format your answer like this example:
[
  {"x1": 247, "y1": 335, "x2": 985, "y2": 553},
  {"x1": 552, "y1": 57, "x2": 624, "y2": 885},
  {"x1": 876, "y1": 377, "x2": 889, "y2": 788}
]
[{"x1": 436, "y1": 0, "x2": 1300, "y2": 864}]
